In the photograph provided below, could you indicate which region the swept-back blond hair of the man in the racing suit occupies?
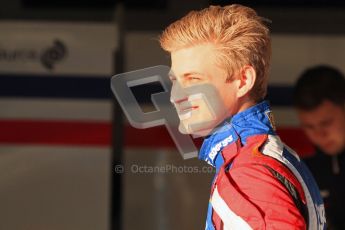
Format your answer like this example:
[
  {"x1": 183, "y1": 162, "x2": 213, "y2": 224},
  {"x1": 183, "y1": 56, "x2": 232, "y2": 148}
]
[{"x1": 159, "y1": 4, "x2": 271, "y2": 101}]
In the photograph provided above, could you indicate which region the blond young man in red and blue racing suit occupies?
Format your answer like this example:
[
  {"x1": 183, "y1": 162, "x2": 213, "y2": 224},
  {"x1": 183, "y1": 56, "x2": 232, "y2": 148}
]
[{"x1": 160, "y1": 5, "x2": 325, "y2": 230}]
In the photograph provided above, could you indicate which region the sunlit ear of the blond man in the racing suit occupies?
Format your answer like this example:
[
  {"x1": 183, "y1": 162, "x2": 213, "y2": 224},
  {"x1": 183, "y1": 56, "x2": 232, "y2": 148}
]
[{"x1": 237, "y1": 65, "x2": 256, "y2": 97}]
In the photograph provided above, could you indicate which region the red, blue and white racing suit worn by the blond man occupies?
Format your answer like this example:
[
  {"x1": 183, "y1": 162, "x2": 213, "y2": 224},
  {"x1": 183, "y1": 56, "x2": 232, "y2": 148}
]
[{"x1": 199, "y1": 101, "x2": 326, "y2": 230}]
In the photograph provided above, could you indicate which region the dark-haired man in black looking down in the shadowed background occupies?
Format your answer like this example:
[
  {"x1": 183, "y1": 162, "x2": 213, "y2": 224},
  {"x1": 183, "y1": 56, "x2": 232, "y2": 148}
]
[{"x1": 294, "y1": 66, "x2": 345, "y2": 229}]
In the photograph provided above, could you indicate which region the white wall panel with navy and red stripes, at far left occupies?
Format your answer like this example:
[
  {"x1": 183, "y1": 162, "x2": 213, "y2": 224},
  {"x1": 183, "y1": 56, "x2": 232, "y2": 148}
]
[{"x1": 0, "y1": 21, "x2": 117, "y2": 230}]
